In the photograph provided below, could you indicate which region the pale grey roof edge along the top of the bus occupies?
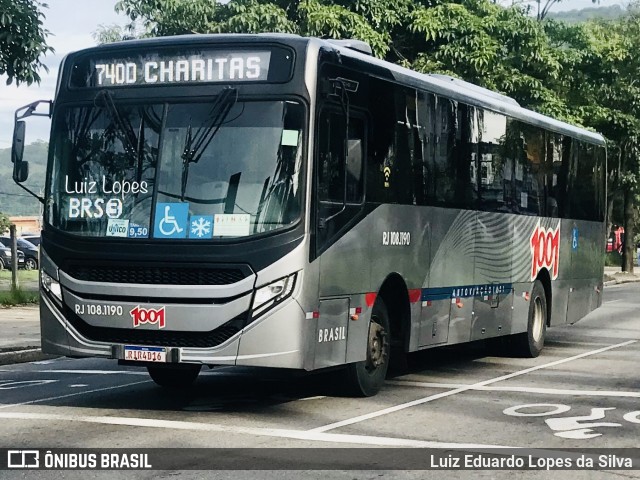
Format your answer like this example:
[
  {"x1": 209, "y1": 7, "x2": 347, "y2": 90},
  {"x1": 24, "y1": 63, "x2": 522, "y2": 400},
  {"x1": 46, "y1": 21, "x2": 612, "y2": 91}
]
[{"x1": 71, "y1": 33, "x2": 605, "y2": 145}]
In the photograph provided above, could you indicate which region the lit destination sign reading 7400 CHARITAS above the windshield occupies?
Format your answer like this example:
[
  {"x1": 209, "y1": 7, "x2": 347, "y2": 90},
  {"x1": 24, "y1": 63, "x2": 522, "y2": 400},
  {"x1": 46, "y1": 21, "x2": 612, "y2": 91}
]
[{"x1": 70, "y1": 47, "x2": 293, "y2": 88}]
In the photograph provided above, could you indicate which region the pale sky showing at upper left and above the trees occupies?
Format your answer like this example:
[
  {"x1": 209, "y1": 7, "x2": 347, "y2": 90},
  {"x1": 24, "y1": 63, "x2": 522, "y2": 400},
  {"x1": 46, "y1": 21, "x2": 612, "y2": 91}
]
[{"x1": 0, "y1": 0, "x2": 627, "y2": 148}]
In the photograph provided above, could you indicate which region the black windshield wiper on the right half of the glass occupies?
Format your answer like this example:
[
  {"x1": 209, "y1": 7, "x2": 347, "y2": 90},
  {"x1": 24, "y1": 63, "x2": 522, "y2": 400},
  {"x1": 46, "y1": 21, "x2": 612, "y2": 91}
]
[{"x1": 180, "y1": 87, "x2": 238, "y2": 201}]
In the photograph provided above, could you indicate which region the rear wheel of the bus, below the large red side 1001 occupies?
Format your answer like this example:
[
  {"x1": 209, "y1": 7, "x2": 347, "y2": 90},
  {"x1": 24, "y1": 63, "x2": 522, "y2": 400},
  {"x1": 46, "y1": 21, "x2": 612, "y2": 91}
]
[{"x1": 512, "y1": 280, "x2": 548, "y2": 358}]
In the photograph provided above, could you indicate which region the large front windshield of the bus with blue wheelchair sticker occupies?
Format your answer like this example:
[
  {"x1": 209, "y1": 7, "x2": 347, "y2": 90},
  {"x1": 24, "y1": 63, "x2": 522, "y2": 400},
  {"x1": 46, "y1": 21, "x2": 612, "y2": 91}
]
[{"x1": 46, "y1": 98, "x2": 304, "y2": 240}]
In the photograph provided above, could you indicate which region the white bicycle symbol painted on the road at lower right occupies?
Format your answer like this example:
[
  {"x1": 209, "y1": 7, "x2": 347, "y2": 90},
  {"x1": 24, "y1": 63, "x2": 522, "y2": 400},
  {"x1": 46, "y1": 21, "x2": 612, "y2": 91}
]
[{"x1": 503, "y1": 403, "x2": 640, "y2": 440}]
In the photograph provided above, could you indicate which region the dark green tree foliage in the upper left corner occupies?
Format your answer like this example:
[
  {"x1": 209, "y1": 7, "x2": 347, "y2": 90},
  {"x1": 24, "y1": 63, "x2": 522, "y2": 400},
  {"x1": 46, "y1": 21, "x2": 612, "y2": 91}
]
[{"x1": 0, "y1": 0, "x2": 53, "y2": 85}]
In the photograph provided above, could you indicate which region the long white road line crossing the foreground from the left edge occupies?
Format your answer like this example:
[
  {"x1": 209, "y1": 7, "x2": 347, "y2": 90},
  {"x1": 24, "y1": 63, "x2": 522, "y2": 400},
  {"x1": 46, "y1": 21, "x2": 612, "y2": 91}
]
[{"x1": 0, "y1": 412, "x2": 516, "y2": 449}]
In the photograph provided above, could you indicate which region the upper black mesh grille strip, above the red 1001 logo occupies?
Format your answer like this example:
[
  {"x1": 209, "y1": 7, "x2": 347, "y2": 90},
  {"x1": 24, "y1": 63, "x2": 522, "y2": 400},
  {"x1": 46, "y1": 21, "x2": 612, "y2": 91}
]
[{"x1": 66, "y1": 264, "x2": 249, "y2": 285}]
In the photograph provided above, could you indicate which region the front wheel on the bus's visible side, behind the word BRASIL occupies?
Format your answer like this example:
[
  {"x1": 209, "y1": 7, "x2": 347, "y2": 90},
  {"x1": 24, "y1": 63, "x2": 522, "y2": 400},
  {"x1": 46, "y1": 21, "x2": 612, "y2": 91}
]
[{"x1": 343, "y1": 297, "x2": 391, "y2": 397}]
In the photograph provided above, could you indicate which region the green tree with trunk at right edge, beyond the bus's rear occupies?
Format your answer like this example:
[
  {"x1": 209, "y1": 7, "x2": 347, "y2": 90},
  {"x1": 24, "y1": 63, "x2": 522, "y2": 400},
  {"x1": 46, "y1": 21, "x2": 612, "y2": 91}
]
[{"x1": 545, "y1": 7, "x2": 640, "y2": 272}]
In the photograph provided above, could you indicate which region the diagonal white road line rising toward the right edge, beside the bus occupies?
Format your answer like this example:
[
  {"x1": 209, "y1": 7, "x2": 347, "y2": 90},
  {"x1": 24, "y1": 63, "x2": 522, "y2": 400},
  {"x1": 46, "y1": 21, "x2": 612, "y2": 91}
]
[{"x1": 309, "y1": 340, "x2": 638, "y2": 432}]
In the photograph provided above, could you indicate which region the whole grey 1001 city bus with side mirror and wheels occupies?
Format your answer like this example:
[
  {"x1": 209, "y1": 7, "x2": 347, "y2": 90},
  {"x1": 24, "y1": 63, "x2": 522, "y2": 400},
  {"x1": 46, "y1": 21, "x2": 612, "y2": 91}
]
[{"x1": 12, "y1": 34, "x2": 606, "y2": 396}]
